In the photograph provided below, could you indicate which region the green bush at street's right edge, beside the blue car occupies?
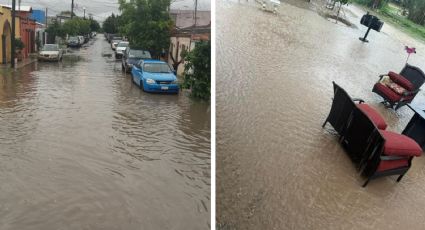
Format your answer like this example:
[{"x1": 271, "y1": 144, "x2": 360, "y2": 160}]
[{"x1": 182, "y1": 41, "x2": 211, "y2": 100}]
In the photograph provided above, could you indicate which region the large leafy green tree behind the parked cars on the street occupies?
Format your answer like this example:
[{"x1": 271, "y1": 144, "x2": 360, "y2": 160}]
[{"x1": 118, "y1": 0, "x2": 173, "y2": 57}]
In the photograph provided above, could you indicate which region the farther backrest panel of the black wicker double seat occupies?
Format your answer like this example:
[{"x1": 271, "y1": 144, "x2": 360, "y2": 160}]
[{"x1": 328, "y1": 82, "x2": 356, "y2": 135}]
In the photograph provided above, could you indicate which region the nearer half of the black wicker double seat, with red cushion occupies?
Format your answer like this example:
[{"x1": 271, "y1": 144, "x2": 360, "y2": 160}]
[{"x1": 342, "y1": 108, "x2": 422, "y2": 187}]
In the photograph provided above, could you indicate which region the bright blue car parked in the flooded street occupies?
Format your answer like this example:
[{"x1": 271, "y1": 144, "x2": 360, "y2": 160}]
[{"x1": 131, "y1": 60, "x2": 179, "y2": 93}]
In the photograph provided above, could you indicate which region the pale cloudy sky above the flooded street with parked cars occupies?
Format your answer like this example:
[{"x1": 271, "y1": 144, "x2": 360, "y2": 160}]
[{"x1": 0, "y1": 0, "x2": 211, "y2": 21}]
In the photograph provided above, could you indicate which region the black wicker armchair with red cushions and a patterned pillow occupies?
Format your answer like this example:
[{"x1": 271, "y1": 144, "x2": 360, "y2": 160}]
[{"x1": 372, "y1": 64, "x2": 425, "y2": 110}]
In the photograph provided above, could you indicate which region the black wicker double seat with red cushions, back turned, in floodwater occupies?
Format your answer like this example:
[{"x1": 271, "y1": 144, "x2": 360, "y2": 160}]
[{"x1": 323, "y1": 82, "x2": 422, "y2": 187}]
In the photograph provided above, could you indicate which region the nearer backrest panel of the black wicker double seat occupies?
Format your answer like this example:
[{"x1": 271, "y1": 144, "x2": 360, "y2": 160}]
[{"x1": 342, "y1": 107, "x2": 385, "y2": 164}]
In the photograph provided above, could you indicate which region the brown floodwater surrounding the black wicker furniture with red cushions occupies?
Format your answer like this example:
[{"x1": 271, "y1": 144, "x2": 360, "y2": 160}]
[{"x1": 216, "y1": 0, "x2": 425, "y2": 230}]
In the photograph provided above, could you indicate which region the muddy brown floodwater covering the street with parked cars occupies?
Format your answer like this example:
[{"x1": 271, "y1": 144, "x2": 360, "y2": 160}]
[{"x1": 0, "y1": 35, "x2": 210, "y2": 230}]
